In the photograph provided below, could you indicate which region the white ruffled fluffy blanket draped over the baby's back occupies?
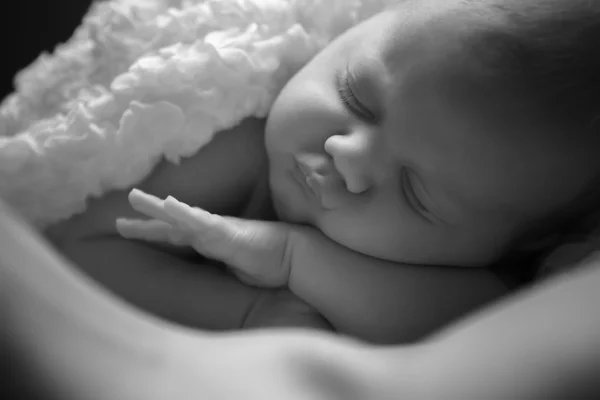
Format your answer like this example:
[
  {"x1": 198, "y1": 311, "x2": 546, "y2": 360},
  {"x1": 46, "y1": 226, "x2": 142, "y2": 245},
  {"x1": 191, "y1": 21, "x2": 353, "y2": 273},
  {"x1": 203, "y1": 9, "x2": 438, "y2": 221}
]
[{"x1": 0, "y1": 0, "x2": 398, "y2": 228}]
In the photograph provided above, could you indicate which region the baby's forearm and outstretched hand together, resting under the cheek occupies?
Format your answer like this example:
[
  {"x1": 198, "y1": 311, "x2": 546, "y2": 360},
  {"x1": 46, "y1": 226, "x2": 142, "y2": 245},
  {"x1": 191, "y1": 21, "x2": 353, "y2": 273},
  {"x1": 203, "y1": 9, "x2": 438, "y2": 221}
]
[{"x1": 118, "y1": 195, "x2": 506, "y2": 343}]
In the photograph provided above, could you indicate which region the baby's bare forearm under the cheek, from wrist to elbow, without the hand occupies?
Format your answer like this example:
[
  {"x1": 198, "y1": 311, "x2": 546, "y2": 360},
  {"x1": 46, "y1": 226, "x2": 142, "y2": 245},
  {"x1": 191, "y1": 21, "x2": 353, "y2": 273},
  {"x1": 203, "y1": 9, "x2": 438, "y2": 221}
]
[{"x1": 289, "y1": 227, "x2": 507, "y2": 343}]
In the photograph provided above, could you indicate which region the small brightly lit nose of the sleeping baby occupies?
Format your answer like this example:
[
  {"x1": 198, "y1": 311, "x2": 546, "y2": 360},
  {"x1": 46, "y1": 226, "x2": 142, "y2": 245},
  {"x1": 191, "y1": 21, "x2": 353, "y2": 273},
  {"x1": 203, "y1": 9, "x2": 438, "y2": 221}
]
[{"x1": 325, "y1": 132, "x2": 373, "y2": 194}]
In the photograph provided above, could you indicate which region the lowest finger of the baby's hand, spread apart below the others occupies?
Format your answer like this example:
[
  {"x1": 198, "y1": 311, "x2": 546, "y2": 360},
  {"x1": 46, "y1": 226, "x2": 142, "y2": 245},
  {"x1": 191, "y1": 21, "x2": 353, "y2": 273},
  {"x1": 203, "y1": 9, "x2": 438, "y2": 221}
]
[{"x1": 116, "y1": 218, "x2": 188, "y2": 245}]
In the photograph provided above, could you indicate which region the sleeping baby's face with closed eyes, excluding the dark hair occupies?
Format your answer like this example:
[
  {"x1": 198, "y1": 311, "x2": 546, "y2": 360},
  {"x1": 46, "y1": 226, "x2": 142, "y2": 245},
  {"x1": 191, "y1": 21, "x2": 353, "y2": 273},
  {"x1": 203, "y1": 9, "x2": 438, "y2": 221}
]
[{"x1": 266, "y1": 2, "x2": 590, "y2": 266}]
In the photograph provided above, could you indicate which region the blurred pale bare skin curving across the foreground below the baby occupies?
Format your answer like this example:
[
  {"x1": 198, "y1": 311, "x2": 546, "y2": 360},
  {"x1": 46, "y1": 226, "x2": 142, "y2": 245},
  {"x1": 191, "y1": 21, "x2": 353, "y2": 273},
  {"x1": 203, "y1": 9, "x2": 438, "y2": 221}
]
[{"x1": 0, "y1": 193, "x2": 600, "y2": 400}]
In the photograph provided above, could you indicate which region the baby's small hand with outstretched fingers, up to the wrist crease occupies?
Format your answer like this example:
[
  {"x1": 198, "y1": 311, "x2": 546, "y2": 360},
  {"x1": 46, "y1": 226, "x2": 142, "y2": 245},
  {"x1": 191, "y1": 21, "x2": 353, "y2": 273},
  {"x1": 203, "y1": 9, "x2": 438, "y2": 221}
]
[{"x1": 117, "y1": 189, "x2": 291, "y2": 287}]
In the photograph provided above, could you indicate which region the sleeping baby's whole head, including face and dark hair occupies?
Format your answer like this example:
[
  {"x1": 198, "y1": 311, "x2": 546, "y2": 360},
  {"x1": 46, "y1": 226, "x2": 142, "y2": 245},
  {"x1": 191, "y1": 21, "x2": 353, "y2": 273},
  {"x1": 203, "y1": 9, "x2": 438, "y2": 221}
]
[{"x1": 266, "y1": 0, "x2": 600, "y2": 266}]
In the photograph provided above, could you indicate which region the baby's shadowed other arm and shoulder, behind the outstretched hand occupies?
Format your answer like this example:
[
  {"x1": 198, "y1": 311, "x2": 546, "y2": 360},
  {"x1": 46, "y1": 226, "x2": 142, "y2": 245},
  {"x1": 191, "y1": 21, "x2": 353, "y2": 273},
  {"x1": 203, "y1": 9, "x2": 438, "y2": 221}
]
[{"x1": 47, "y1": 119, "x2": 276, "y2": 329}]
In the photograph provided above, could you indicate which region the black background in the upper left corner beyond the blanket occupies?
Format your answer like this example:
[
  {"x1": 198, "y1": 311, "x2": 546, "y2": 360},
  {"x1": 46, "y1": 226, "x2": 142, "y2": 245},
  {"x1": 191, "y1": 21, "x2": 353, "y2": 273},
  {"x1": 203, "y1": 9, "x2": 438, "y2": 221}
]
[{"x1": 0, "y1": 0, "x2": 92, "y2": 99}]
